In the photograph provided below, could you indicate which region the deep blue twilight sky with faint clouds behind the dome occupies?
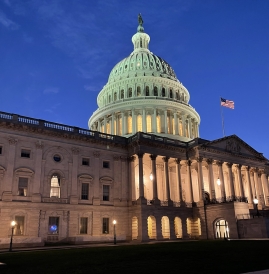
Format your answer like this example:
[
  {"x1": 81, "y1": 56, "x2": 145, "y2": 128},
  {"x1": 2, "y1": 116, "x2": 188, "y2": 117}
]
[{"x1": 0, "y1": 0, "x2": 269, "y2": 158}]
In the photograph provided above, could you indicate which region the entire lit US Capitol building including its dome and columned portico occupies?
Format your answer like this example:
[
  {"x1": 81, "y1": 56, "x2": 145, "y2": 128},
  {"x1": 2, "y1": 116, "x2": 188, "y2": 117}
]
[{"x1": 0, "y1": 15, "x2": 269, "y2": 248}]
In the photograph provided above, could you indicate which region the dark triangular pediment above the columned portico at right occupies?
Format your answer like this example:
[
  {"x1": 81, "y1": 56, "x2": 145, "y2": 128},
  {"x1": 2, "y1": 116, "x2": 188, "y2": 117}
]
[{"x1": 200, "y1": 135, "x2": 268, "y2": 161}]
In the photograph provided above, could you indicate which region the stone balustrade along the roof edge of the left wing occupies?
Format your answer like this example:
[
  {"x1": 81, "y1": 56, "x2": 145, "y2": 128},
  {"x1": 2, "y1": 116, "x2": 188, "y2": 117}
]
[{"x1": 0, "y1": 112, "x2": 127, "y2": 145}]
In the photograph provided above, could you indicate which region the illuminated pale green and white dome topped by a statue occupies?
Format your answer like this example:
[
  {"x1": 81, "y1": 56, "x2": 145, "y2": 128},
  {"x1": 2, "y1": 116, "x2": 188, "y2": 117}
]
[{"x1": 89, "y1": 17, "x2": 200, "y2": 141}]
